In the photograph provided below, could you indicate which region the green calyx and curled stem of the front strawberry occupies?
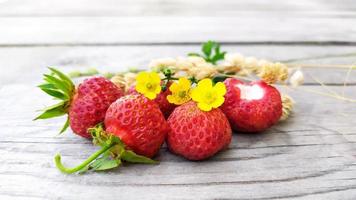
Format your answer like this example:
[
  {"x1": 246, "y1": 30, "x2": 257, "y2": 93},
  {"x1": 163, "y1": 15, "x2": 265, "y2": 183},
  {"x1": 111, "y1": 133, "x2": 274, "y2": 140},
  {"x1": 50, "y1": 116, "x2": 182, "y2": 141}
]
[{"x1": 54, "y1": 123, "x2": 157, "y2": 174}]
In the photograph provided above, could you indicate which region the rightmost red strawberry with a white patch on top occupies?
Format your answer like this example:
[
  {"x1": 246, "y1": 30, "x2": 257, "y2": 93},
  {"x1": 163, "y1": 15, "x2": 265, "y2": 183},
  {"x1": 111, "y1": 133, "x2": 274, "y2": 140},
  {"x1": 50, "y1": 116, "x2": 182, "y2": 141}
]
[{"x1": 221, "y1": 78, "x2": 282, "y2": 132}]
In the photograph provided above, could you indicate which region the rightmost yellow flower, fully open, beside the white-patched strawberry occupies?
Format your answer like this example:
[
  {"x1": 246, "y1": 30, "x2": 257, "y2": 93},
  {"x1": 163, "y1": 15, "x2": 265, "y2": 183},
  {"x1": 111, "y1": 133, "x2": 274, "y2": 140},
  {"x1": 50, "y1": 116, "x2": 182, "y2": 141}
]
[{"x1": 192, "y1": 78, "x2": 226, "y2": 111}]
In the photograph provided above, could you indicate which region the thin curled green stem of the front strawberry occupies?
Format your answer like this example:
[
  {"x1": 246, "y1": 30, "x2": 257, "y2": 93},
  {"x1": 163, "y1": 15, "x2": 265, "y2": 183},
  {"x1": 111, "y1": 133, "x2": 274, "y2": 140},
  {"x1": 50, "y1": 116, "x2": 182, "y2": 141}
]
[{"x1": 54, "y1": 142, "x2": 116, "y2": 174}]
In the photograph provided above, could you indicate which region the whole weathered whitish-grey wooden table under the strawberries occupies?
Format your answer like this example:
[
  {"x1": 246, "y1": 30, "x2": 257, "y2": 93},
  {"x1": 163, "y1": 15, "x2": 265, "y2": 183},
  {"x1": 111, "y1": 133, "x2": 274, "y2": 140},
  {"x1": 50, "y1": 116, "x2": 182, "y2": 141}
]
[{"x1": 0, "y1": 0, "x2": 356, "y2": 200}]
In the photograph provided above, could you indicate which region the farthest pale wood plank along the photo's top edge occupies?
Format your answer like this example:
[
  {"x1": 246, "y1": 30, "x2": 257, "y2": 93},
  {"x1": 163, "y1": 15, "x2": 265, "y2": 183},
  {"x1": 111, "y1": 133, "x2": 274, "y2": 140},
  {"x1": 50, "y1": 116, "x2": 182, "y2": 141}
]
[{"x1": 0, "y1": 0, "x2": 356, "y2": 17}]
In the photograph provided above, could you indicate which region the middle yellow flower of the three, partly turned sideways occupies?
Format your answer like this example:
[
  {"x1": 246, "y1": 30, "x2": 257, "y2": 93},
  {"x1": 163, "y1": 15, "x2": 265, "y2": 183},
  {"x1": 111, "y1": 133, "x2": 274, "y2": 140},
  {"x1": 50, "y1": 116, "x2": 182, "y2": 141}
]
[{"x1": 167, "y1": 77, "x2": 191, "y2": 105}]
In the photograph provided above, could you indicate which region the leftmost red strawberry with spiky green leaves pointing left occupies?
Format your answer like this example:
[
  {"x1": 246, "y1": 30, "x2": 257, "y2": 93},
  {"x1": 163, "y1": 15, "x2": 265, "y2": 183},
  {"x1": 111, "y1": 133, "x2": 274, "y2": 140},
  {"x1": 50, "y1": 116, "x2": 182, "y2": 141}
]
[{"x1": 36, "y1": 68, "x2": 124, "y2": 138}]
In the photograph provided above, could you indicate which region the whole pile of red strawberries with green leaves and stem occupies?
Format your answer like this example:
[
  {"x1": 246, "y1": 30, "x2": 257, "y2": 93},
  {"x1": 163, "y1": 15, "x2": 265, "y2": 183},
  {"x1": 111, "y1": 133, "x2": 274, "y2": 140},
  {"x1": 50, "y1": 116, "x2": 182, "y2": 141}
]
[{"x1": 36, "y1": 68, "x2": 282, "y2": 173}]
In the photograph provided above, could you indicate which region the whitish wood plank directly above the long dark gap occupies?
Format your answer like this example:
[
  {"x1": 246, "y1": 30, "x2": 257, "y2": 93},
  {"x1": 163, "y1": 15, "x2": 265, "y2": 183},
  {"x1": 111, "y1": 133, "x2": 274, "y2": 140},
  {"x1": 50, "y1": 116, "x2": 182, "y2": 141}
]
[{"x1": 0, "y1": 16, "x2": 356, "y2": 46}]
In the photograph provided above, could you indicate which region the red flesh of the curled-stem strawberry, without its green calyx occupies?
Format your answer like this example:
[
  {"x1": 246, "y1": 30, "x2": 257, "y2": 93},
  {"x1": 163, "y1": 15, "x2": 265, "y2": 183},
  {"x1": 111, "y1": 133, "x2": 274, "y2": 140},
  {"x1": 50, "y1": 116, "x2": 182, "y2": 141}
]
[{"x1": 105, "y1": 95, "x2": 169, "y2": 157}]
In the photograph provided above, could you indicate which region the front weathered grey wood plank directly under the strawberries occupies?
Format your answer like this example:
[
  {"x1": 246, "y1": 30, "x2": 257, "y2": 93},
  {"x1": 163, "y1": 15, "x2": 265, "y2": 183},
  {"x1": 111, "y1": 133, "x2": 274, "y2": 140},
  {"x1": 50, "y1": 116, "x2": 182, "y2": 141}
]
[{"x1": 0, "y1": 84, "x2": 356, "y2": 199}]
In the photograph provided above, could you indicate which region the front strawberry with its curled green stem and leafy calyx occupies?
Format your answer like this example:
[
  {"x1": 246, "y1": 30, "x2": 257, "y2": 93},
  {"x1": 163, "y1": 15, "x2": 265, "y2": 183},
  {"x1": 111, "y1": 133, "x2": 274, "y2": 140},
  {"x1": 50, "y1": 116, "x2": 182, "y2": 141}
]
[{"x1": 55, "y1": 95, "x2": 169, "y2": 174}]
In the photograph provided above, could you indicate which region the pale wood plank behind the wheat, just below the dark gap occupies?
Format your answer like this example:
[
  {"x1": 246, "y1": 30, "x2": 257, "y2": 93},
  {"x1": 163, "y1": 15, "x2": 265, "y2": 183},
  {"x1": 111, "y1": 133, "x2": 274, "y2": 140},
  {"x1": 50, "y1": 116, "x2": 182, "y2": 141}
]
[{"x1": 0, "y1": 45, "x2": 356, "y2": 85}]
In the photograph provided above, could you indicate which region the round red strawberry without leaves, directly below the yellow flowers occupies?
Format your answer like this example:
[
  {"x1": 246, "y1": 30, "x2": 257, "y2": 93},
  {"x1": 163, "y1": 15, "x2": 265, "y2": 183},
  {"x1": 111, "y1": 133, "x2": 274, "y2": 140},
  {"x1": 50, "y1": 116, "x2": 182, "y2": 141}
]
[{"x1": 167, "y1": 101, "x2": 231, "y2": 160}]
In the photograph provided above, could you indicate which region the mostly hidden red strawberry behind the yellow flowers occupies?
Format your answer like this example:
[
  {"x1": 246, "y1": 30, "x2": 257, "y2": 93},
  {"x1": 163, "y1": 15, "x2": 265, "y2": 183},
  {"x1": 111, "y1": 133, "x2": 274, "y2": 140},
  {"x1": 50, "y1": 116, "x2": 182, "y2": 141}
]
[{"x1": 128, "y1": 82, "x2": 176, "y2": 118}]
